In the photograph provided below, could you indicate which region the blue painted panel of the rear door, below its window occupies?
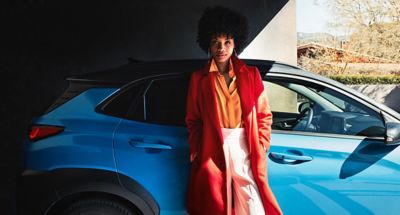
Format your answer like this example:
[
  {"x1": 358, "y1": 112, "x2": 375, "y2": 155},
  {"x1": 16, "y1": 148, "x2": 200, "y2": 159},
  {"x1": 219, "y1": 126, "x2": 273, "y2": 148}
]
[{"x1": 114, "y1": 120, "x2": 190, "y2": 214}]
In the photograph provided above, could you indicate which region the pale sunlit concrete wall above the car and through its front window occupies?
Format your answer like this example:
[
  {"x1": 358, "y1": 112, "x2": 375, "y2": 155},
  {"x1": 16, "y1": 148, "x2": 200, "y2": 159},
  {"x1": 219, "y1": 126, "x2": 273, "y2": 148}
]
[{"x1": 240, "y1": 0, "x2": 297, "y2": 112}]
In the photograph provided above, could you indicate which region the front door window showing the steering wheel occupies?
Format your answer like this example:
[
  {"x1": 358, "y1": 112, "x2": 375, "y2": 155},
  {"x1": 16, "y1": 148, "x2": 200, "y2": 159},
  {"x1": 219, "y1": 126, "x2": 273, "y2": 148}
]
[{"x1": 265, "y1": 80, "x2": 385, "y2": 137}]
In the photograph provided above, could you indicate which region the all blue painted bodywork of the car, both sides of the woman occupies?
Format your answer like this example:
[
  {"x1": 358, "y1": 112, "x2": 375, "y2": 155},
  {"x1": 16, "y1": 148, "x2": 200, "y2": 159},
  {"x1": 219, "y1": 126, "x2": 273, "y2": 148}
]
[{"x1": 25, "y1": 88, "x2": 400, "y2": 215}]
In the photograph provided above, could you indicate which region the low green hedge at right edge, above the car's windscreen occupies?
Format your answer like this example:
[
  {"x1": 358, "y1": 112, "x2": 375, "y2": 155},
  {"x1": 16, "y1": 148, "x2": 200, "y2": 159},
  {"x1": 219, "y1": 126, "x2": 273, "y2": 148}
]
[{"x1": 329, "y1": 75, "x2": 400, "y2": 84}]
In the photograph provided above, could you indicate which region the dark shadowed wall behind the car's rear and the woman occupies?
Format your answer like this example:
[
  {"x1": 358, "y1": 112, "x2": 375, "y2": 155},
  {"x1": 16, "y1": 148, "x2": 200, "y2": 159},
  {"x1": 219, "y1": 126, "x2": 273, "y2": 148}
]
[{"x1": 0, "y1": 0, "x2": 287, "y2": 214}]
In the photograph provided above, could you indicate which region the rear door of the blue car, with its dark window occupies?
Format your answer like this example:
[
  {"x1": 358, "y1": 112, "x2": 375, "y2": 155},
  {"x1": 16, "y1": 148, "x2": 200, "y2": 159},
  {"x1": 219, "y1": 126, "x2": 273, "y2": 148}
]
[{"x1": 110, "y1": 75, "x2": 190, "y2": 214}]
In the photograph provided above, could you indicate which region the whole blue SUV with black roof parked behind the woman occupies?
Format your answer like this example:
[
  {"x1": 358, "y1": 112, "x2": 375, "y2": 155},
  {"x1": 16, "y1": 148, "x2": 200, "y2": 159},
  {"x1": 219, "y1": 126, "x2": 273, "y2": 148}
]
[{"x1": 21, "y1": 60, "x2": 400, "y2": 215}]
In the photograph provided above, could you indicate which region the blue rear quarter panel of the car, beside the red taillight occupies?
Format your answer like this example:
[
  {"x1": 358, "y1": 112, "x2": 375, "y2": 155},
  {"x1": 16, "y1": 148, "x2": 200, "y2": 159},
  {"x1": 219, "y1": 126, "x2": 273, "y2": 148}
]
[{"x1": 24, "y1": 89, "x2": 120, "y2": 171}]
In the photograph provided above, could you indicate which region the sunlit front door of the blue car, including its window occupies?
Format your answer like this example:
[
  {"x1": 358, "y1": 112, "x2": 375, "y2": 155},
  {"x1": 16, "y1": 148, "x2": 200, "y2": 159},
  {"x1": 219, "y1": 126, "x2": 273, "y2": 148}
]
[{"x1": 265, "y1": 77, "x2": 400, "y2": 214}]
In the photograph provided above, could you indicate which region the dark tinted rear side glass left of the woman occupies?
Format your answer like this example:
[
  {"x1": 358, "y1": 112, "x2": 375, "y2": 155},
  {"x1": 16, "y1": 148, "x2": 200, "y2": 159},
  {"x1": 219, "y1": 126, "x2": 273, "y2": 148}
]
[{"x1": 100, "y1": 75, "x2": 190, "y2": 126}]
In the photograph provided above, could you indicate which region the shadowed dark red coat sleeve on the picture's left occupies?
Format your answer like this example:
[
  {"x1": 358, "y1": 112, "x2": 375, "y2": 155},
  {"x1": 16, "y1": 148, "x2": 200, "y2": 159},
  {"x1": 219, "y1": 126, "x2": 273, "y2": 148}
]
[{"x1": 185, "y1": 72, "x2": 203, "y2": 159}]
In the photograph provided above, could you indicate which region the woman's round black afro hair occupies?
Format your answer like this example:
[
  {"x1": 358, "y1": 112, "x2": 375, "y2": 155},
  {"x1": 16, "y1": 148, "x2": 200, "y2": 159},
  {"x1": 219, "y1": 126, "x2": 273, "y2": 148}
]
[{"x1": 197, "y1": 6, "x2": 248, "y2": 54}]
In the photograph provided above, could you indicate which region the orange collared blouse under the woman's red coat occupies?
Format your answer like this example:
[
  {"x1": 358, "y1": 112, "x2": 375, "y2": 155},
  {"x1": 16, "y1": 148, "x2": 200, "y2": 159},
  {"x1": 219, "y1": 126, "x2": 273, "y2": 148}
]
[{"x1": 210, "y1": 59, "x2": 243, "y2": 128}]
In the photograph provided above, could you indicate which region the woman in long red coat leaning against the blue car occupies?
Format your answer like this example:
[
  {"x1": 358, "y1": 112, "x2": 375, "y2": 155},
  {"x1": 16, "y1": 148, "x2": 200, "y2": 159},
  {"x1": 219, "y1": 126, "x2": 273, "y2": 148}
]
[{"x1": 186, "y1": 7, "x2": 282, "y2": 215}]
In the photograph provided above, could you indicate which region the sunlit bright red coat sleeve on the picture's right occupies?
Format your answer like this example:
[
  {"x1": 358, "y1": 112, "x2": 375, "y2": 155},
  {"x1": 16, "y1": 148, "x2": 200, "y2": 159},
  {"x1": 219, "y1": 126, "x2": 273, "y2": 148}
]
[{"x1": 254, "y1": 68, "x2": 272, "y2": 151}]
